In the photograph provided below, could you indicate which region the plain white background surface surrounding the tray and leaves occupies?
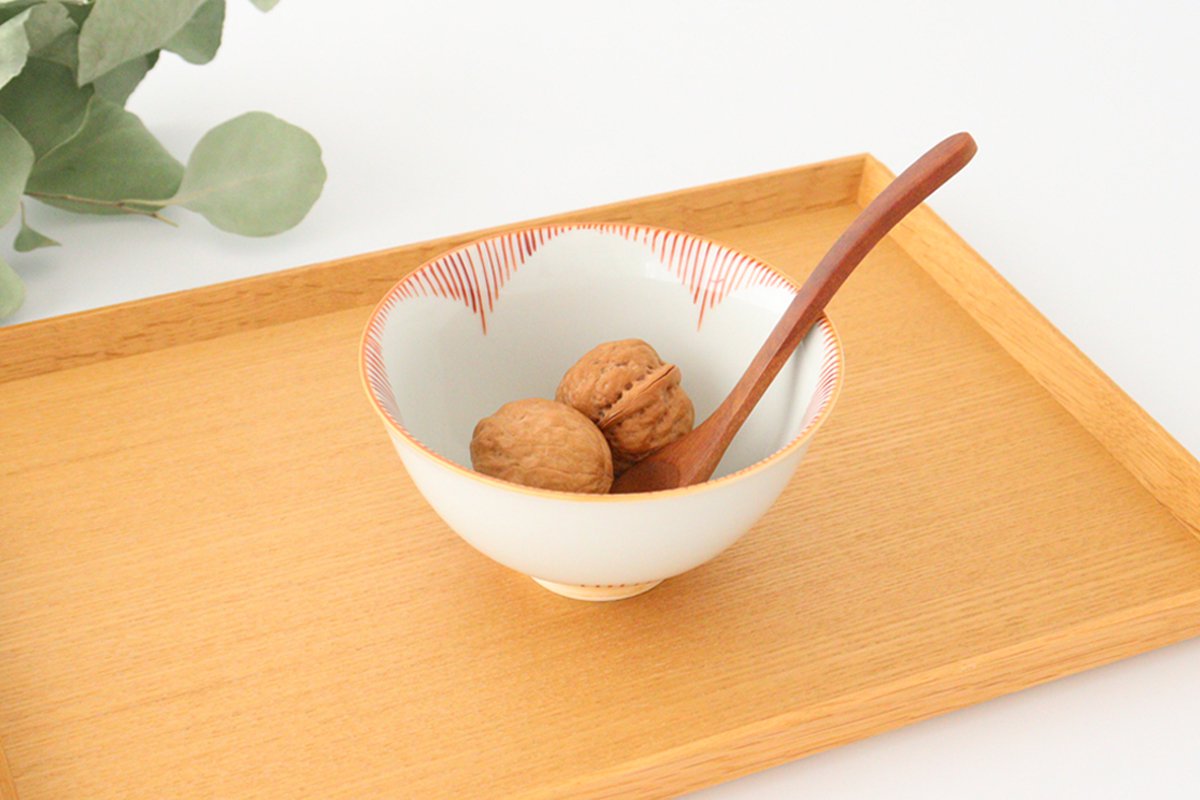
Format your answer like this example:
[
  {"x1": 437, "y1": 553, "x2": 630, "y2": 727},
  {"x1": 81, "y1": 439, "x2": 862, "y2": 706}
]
[{"x1": 5, "y1": 0, "x2": 1200, "y2": 800}]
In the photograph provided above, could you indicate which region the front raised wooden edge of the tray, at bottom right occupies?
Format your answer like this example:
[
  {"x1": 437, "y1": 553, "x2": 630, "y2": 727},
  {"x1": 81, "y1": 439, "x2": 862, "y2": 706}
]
[{"x1": 520, "y1": 590, "x2": 1200, "y2": 800}]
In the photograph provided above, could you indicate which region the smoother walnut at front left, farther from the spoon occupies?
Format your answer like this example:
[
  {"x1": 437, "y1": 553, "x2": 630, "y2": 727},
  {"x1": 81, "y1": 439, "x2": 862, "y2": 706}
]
[{"x1": 470, "y1": 397, "x2": 612, "y2": 494}]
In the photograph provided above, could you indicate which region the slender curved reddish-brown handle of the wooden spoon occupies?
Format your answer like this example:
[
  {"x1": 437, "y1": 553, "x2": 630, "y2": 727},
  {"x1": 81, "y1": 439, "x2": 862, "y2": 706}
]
[{"x1": 698, "y1": 133, "x2": 976, "y2": 481}]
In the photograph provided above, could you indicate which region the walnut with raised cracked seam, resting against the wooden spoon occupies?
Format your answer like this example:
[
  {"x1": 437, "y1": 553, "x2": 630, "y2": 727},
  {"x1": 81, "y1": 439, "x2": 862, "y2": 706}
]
[{"x1": 556, "y1": 339, "x2": 696, "y2": 475}]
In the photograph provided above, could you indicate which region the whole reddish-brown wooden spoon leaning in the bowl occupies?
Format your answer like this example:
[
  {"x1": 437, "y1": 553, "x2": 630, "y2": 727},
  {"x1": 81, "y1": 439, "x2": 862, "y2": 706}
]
[{"x1": 612, "y1": 133, "x2": 976, "y2": 494}]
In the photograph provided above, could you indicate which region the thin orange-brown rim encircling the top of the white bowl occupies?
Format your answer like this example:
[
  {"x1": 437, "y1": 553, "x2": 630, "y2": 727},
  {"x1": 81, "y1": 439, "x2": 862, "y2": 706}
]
[{"x1": 359, "y1": 222, "x2": 846, "y2": 503}]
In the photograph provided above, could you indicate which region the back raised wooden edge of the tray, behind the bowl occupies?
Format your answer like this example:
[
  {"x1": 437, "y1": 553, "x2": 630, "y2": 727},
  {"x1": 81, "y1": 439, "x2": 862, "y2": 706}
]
[{"x1": 0, "y1": 156, "x2": 863, "y2": 381}]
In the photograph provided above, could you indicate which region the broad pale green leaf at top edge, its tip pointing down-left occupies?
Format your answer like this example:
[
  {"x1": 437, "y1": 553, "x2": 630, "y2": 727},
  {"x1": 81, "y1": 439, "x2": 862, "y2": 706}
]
[{"x1": 78, "y1": 0, "x2": 203, "y2": 85}]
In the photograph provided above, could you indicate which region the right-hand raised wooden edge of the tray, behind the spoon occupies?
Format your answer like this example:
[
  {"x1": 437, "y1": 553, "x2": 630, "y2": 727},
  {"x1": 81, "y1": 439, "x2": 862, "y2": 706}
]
[{"x1": 858, "y1": 156, "x2": 1200, "y2": 536}]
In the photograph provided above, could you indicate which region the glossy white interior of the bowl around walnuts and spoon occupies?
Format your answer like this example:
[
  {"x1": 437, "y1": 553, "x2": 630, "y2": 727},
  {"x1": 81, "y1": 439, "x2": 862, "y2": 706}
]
[{"x1": 364, "y1": 225, "x2": 835, "y2": 477}]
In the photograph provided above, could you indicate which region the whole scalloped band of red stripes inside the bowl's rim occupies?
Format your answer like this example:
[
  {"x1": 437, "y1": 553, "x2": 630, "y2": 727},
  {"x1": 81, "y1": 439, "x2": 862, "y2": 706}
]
[{"x1": 362, "y1": 223, "x2": 841, "y2": 471}]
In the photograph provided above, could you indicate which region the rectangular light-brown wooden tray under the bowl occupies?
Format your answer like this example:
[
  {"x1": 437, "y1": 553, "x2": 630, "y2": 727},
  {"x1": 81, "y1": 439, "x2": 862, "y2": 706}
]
[{"x1": 0, "y1": 156, "x2": 1200, "y2": 800}]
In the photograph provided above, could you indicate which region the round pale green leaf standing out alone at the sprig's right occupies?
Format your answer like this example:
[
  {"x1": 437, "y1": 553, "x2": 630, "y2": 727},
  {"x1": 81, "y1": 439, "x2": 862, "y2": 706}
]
[{"x1": 172, "y1": 112, "x2": 325, "y2": 236}]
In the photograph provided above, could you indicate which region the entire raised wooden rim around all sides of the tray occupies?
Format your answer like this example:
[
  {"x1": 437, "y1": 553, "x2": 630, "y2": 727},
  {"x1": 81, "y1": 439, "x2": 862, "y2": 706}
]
[{"x1": 0, "y1": 154, "x2": 1200, "y2": 800}]
